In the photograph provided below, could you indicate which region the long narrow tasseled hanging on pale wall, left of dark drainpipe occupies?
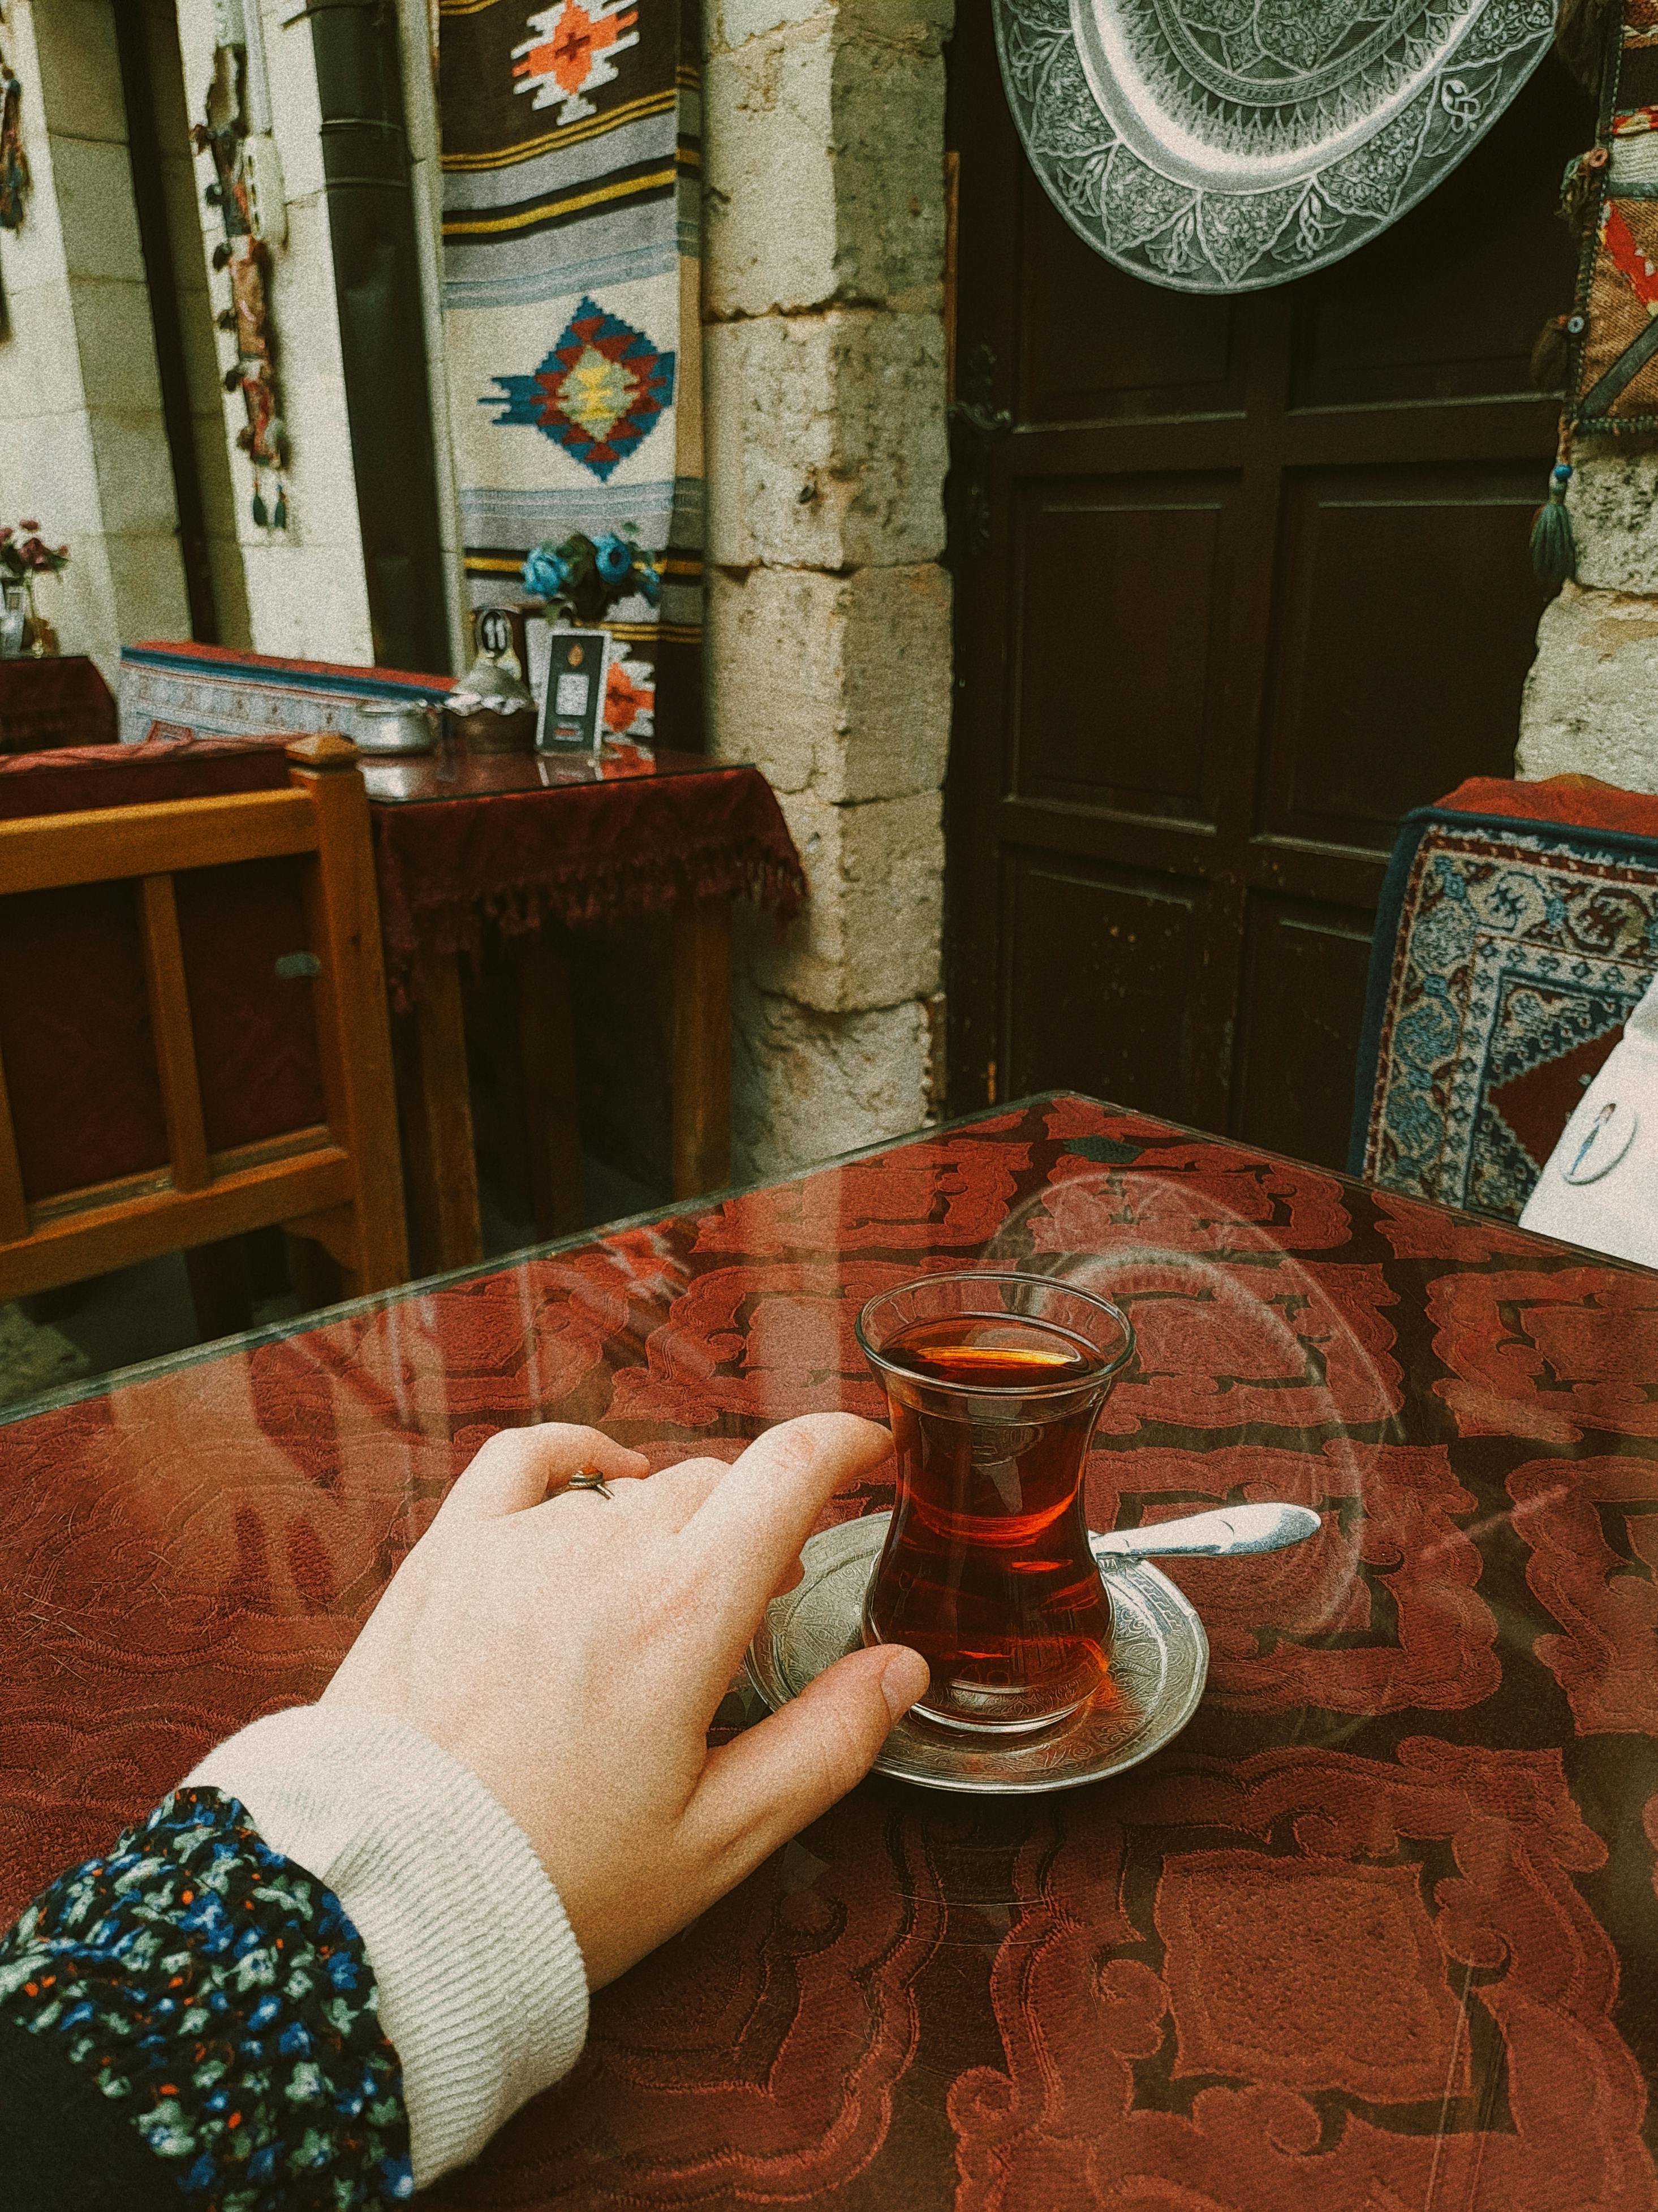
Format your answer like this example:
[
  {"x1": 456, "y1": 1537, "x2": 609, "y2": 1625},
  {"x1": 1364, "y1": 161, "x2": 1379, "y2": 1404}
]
[{"x1": 190, "y1": 46, "x2": 287, "y2": 531}]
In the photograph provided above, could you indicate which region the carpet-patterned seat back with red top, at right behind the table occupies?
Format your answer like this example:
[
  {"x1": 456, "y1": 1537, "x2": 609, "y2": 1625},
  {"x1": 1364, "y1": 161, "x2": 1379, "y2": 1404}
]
[{"x1": 1349, "y1": 778, "x2": 1658, "y2": 1221}]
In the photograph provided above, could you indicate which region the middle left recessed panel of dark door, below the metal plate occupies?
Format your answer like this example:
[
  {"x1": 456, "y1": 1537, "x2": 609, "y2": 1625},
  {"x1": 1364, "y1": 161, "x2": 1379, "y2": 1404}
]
[{"x1": 1013, "y1": 478, "x2": 1225, "y2": 819}]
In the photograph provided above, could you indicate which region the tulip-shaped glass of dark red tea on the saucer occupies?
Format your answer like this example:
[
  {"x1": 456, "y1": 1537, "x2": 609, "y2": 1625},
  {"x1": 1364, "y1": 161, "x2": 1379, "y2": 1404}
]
[{"x1": 858, "y1": 1274, "x2": 1134, "y2": 1734}]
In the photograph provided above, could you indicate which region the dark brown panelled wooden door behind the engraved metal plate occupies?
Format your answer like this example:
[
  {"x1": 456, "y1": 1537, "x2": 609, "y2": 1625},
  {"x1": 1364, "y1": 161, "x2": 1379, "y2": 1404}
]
[{"x1": 946, "y1": 17, "x2": 1592, "y2": 1164}]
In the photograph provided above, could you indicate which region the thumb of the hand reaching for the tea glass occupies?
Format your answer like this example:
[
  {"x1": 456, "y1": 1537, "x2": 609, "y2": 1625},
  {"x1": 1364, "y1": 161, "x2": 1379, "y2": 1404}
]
[{"x1": 687, "y1": 1643, "x2": 928, "y2": 1889}]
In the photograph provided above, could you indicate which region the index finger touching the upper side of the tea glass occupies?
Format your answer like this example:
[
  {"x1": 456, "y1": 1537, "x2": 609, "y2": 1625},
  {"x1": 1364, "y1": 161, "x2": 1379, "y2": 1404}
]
[{"x1": 685, "y1": 1413, "x2": 893, "y2": 1646}]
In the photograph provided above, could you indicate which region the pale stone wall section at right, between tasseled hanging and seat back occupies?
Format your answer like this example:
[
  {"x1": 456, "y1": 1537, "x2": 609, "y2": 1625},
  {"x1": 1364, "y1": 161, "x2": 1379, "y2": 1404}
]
[{"x1": 1514, "y1": 442, "x2": 1658, "y2": 792}]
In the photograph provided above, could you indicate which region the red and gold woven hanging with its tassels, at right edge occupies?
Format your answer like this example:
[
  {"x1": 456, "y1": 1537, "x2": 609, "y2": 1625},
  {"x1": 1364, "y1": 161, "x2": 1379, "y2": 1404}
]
[{"x1": 1532, "y1": 0, "x2": 1658, "y2": 584}]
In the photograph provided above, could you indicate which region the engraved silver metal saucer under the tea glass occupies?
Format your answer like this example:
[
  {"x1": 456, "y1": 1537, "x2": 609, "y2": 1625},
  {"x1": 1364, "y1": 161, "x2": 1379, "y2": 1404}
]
[{"x1": 747, "y1": 1513, "x2": 1209, "y2": 1796}]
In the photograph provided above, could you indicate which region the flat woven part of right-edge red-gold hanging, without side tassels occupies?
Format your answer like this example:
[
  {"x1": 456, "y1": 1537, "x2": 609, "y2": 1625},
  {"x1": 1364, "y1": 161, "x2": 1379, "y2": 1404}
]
[{"x1": 1567, "y1": 0, "x2": 1658, "y2": 438}]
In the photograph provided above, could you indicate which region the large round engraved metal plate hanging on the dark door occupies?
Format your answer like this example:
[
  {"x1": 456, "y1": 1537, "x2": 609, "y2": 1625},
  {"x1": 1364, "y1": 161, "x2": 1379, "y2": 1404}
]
[{"x1": 993, "y1": 0, "x2": 1554, "y2": 292}]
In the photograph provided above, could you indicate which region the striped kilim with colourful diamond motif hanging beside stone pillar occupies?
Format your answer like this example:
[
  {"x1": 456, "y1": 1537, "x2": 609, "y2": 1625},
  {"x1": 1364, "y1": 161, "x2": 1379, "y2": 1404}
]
[{"x1": 438, "y1": 0, "x2": 703, "y2": 743}]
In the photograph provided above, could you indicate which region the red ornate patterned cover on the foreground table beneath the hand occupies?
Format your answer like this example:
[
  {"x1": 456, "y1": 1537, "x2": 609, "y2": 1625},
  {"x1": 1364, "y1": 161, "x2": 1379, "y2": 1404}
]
[{"x1": 0, "y1": 1097, "x2": 1658, "y2": 2212}]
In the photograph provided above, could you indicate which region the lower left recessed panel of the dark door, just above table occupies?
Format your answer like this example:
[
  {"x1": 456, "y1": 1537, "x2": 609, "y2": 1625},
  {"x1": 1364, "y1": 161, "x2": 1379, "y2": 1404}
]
[{"x1": 1004, "y1": 851, "x2": 1207, "y2": 1115}]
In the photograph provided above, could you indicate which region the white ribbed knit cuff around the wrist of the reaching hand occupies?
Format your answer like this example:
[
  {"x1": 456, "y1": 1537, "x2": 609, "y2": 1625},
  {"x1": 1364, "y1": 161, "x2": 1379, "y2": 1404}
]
[{"x1": 186, "y1": 1706, "x2": 588, "y2": 2188}]
